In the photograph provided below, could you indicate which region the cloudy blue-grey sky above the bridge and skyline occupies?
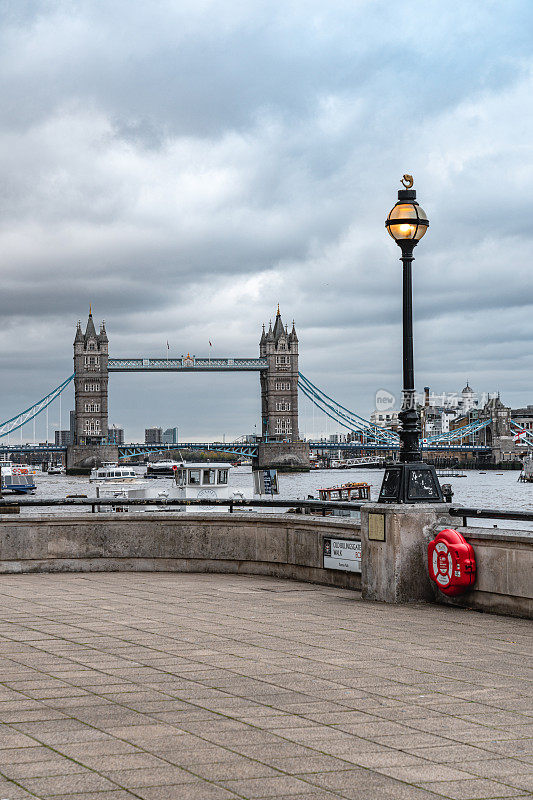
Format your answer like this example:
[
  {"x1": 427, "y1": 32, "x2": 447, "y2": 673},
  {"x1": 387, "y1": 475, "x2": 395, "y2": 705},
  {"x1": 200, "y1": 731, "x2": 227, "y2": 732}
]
[{"x1": 0, "y1": 0, "x2": 533, "y2": 441}]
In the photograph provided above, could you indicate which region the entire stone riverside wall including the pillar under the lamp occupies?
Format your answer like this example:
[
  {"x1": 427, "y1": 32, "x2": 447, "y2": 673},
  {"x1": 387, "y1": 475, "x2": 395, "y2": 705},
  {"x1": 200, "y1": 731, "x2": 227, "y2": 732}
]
[{"x1": 0, "y1": 510, "x2": 533, "y2": 618}]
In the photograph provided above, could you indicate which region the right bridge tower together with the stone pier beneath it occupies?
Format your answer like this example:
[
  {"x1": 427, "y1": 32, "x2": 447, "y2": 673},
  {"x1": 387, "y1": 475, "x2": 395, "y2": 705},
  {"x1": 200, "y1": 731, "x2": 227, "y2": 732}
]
[{"x1": 258, "y1": 305, "x2": 309, "y2": 469}]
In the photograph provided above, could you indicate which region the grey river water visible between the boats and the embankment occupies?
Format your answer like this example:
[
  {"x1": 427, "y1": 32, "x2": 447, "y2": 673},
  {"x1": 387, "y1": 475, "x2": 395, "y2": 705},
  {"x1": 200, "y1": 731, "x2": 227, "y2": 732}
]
[{"x1": 15, "y1": 467, "x2": 533, "y2": 529}]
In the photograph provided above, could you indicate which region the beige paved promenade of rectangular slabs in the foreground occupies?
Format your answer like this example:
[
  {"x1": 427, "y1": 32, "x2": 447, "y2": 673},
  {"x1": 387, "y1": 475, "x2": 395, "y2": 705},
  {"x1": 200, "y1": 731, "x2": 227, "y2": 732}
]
[{"x1": 0, "y1": 573, "x2": 533, "y2": 800}]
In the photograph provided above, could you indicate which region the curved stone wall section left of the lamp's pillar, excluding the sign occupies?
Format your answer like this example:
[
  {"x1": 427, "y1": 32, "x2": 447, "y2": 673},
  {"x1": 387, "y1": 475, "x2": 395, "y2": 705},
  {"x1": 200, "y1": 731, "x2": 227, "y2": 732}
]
[{"x1": 0, "y1": 512, "x2": 361, "y2": 589}]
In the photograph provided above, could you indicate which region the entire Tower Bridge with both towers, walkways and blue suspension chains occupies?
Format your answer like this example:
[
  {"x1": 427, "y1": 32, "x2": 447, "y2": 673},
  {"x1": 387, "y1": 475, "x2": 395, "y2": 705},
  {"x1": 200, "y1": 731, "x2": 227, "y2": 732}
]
[{"x1": 0, "y1": 306, "x2": 520, "y2": 469}]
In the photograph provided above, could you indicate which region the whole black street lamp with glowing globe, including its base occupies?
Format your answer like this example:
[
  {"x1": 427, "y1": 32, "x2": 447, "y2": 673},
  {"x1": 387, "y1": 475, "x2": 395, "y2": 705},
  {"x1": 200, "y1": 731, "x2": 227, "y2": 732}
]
[{"x1": 379, "y1": 175, "x2": 444, "y2": 503}]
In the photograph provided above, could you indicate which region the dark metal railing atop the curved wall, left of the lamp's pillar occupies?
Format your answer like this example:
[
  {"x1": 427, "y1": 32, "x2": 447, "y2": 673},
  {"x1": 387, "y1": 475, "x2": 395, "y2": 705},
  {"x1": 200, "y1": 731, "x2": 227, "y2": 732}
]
[{"x1": 0, "y1": 497, "x2": 363, "y2": 516}]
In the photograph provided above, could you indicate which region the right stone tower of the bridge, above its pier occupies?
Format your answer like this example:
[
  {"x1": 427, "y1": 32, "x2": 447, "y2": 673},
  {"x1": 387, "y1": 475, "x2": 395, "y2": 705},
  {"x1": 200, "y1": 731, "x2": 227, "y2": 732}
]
[{"x1": 259, "y1": 305, "x2": 300, "y2": 442}]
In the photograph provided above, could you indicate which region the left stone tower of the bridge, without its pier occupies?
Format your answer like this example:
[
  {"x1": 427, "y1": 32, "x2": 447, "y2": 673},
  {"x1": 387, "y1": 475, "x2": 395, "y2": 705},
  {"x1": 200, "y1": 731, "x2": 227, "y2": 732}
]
[{"x1": 74, "y1": 310, "x2": 109, "y2": 445}]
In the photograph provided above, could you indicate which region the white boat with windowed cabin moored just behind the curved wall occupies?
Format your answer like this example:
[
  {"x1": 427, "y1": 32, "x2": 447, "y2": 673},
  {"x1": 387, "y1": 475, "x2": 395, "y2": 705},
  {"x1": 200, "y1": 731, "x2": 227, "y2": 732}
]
[{"x1": 97, "y1": 462, "x2": 253, "y2": 511}]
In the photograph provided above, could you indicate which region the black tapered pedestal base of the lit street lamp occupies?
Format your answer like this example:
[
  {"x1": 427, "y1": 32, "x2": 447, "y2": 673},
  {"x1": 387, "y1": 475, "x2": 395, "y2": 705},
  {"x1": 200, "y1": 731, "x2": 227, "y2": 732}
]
[{"x1": 378, "y1": 461, "x2": 444, "y2": 503}]
